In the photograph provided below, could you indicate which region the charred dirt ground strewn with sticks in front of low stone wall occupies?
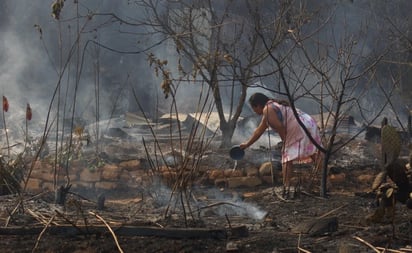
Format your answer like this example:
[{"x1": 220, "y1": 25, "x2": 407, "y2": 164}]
[{"x1": 0, "y1": 138, "x2": 412, "y2": 253}]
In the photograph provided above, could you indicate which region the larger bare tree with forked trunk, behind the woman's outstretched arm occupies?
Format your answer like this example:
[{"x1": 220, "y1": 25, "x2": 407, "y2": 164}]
[{"x1": 139, "y1": 0, "x2": 306, "y2": 147}]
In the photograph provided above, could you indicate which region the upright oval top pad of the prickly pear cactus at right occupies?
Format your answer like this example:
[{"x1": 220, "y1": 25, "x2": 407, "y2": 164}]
[{"x1": 381, "y1": 125, "x2": 401, "y2": 166}]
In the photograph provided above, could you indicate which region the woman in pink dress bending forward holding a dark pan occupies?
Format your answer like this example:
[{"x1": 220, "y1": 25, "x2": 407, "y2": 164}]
[{"x1": 240, "y1": 93, "x2": 321, "y2": 197}]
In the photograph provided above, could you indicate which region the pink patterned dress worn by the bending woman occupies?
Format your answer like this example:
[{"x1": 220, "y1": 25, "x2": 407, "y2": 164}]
[{"x1": 268, "y1": 101, "x2": 321, "y2": 163}]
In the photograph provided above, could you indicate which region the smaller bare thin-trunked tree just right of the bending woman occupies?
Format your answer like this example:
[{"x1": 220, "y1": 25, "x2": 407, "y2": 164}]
[{"x1": 258, "y1": 0, "x2": 399, "y2": 196}]
